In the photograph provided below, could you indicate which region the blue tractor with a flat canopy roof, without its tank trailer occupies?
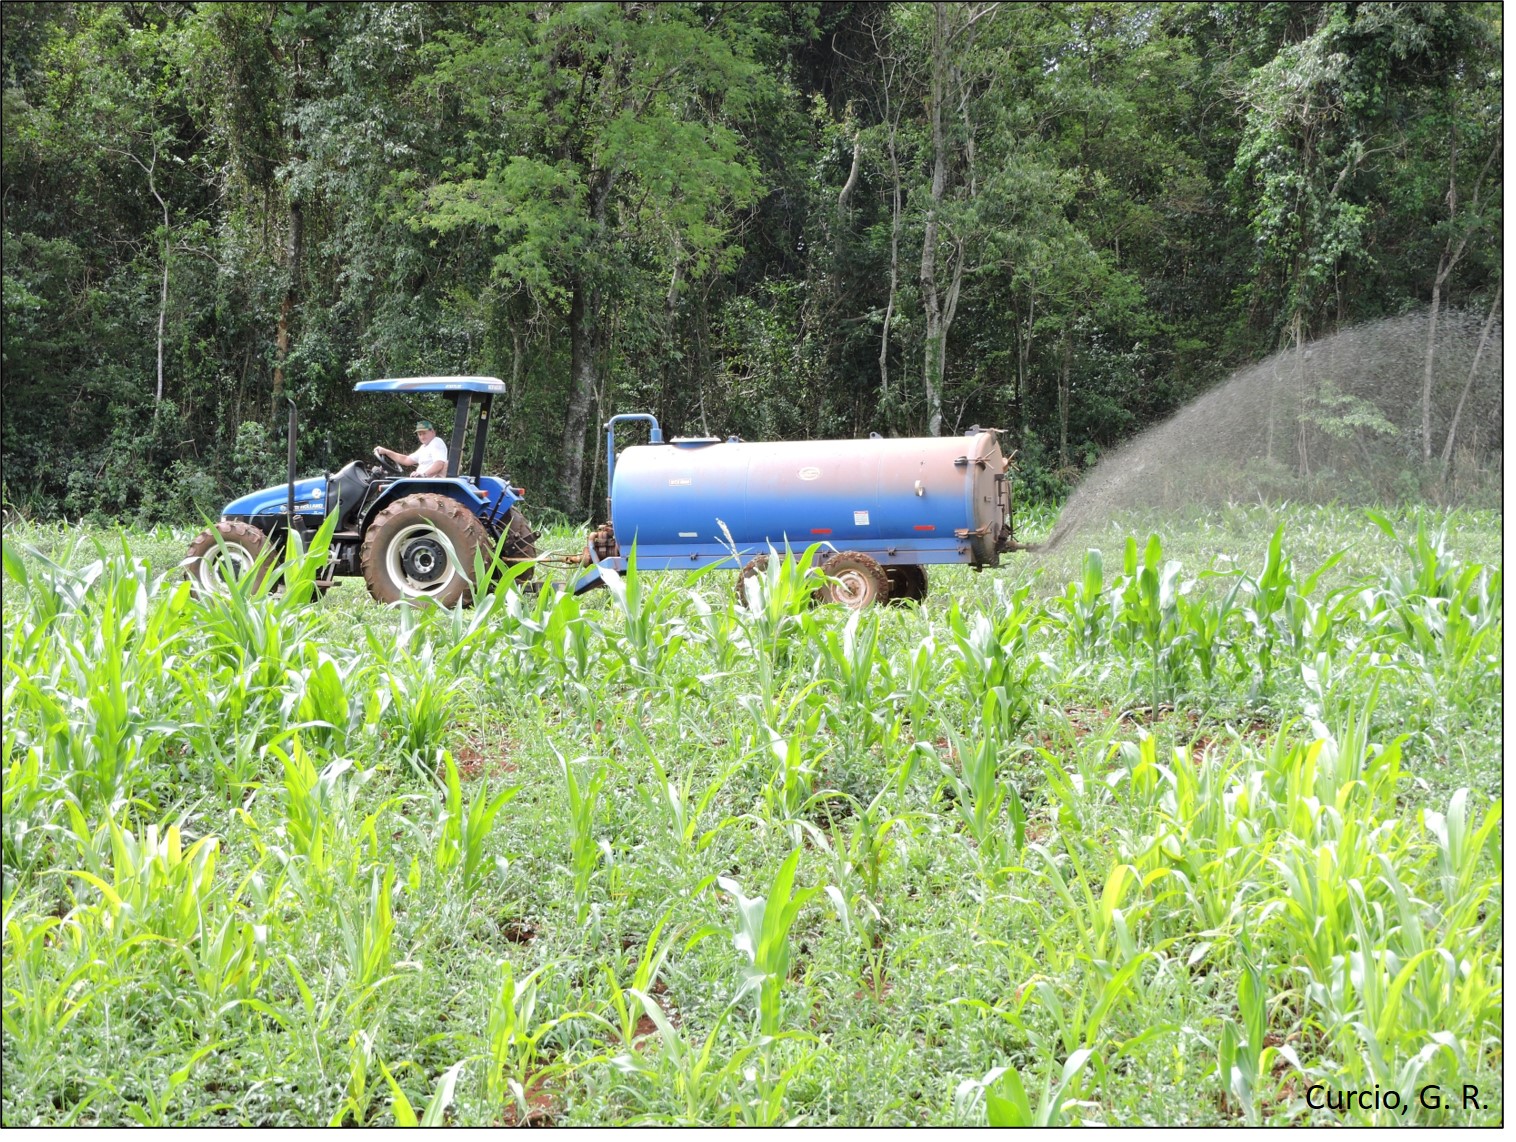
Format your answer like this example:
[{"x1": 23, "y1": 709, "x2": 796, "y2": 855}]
[{"x1": 185, "y1": 376, "x2": 537, "y2": 607}]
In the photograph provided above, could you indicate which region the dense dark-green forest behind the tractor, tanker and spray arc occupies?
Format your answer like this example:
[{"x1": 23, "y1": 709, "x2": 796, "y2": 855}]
[{"x1": 0, "y1": 3, "x2": 1504, "y2": 522}]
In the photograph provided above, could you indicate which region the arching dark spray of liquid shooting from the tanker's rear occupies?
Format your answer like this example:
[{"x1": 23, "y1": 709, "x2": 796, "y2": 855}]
[{"x1": 1045, "y1": 311, "x2": 1502, "y2": 549}]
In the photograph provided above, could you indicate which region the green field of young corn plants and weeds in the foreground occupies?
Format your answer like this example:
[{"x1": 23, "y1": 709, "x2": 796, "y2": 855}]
[{"x1": 3, "y1": 507, "x2": 1504, "y2": 1125}]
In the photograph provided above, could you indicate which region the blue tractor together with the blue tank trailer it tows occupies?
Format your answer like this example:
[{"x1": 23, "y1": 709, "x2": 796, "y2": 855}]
[{"x1": 185, "y1": 376, "x2": 1025, "y2": 610}]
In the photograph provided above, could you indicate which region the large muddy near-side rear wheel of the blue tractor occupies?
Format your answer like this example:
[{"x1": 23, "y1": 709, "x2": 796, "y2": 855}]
[{"x1": 359, "y1": 493, "x2": 490, "y2": 607}]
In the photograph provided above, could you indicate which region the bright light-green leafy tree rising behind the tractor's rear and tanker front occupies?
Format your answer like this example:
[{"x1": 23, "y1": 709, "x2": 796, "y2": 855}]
[{"x1": 412, "y1": 5, "x2": 766, "y2": 514}]
